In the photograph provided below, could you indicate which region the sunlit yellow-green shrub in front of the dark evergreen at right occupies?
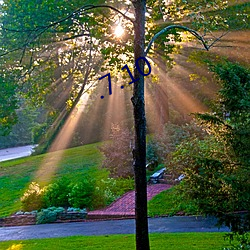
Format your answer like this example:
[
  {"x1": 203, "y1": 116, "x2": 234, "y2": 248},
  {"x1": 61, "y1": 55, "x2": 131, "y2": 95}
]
[{"x1": 168, "y1": 137, "x2": 238, "y2": 214}]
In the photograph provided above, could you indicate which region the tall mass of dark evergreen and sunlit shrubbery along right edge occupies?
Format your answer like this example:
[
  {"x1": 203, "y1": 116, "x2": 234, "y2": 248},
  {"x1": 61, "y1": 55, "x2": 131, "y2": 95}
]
[{"x1": 169, "y1": 62, "x2": 250, "y2": 233}]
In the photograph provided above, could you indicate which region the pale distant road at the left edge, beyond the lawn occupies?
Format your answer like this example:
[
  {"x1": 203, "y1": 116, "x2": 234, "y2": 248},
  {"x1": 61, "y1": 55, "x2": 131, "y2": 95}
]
[{"x1": 0, "y1": 145, "x2": 35, "y2": 162}]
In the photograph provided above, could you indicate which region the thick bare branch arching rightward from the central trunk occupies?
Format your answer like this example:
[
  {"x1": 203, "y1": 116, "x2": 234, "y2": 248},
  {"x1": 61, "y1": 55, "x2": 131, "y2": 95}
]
[{"x1": 145, "y1": 25, "x2": 211, "y2": 56}]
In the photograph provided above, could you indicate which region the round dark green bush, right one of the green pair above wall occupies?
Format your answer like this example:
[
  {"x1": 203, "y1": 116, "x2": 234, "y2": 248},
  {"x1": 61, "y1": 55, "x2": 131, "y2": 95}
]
[{"x1": 68, "y1": 179, "x2": 94, "y2": 208}]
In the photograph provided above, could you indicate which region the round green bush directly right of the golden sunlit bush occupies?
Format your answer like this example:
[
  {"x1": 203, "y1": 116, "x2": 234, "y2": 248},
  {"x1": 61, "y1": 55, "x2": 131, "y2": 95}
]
[{"x1": 43, "y1": 178, "x2": 71, "y2": 207}]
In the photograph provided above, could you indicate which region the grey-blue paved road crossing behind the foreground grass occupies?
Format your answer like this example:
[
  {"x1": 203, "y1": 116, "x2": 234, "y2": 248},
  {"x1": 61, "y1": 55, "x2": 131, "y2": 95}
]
[{"x1": 0, "y1": 216, "x2": 229, "y2": 241}]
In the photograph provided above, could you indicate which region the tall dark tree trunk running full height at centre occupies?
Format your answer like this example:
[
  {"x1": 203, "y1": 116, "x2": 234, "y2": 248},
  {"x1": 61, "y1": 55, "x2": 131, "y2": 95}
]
[{"x1": 132, "y1": 0, "x2": 149, "y2": 250}]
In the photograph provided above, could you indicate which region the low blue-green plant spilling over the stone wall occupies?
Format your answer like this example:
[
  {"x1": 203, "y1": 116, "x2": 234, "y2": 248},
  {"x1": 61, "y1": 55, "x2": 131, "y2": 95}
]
[{"x1": 36, "y1": 207, "x2": 64, "y2": 224}]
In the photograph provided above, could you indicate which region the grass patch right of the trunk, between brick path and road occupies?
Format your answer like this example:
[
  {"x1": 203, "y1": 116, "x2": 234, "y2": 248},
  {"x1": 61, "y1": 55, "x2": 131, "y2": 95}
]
[{"x1": 148, "y1": 187, "x2": 198, "y2": 217}]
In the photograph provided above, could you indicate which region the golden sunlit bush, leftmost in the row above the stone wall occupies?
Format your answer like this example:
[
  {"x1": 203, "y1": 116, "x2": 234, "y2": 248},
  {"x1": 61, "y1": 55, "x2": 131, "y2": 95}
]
[{"x1": 21, "y1": 182, "x2": 45, "y2": 211}]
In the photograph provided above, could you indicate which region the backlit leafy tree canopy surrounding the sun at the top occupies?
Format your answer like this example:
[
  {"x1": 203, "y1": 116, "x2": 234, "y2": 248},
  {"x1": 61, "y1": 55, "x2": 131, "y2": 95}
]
[{"x1": 0, "y1": 0, "x2": 238, "y2": 129}]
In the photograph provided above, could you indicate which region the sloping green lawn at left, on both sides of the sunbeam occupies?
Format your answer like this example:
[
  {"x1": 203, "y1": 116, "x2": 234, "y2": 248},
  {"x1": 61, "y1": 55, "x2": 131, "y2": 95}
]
[{"x1": 0, "y1": 143, "x2": 103, "y2": 217}]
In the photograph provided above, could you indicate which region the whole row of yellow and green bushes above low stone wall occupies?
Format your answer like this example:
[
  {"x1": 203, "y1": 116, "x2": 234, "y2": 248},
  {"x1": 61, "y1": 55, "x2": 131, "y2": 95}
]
[{"x1": 21, "y1": 169, "x2": 134, "y2": 212}]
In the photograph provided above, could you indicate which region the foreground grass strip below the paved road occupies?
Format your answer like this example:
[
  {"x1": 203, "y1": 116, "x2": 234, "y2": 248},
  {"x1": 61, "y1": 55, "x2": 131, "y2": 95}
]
[{"x1": 0, "y1": 233, "x2": 228, "y2": 250}]
